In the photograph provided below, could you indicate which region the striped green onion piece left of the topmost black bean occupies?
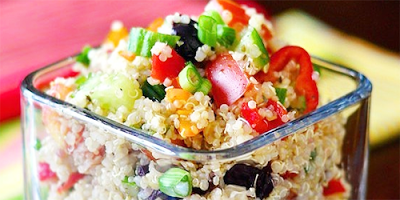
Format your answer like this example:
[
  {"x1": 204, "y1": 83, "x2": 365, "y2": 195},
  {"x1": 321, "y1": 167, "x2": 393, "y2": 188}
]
[{"x1": 128, "y1": 28, "x2": 180, "y2": 57}]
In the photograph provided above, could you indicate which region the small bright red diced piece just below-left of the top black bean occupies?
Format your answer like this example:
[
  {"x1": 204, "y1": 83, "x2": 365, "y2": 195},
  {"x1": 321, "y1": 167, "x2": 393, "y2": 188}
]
[{"x1": 151, "y1": 49, "x2": 185, "y2": 83}]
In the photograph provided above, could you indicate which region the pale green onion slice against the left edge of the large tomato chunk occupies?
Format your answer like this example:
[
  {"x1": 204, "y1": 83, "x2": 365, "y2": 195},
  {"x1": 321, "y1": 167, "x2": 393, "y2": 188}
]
[{"x1": 178, "y1": 62, "x2": 202, "y2": 93}]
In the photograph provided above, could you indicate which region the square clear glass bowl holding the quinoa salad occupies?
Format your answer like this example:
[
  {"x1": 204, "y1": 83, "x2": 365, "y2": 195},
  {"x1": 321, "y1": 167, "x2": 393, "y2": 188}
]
[{"x1": 21, "y1": 55, "x2": 372, "y2": 200}]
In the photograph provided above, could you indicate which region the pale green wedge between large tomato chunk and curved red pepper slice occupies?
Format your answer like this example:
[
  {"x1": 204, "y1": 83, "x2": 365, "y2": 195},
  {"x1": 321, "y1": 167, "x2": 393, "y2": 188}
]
[{"x1": 236, "y1": 27, "x2": 269, "y2": 71}]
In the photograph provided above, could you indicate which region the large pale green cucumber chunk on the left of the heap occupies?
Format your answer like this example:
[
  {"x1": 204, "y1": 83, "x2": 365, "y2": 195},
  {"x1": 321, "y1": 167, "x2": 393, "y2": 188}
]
[{"x1": 76, "y1": 74, "x2": 142, "y2": 112}]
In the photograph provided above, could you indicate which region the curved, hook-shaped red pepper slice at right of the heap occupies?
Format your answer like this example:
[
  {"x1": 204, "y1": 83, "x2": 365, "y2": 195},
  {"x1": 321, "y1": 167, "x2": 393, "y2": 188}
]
[{"x1": 255, "y1": 46, "x2": 319, "y2": 113}]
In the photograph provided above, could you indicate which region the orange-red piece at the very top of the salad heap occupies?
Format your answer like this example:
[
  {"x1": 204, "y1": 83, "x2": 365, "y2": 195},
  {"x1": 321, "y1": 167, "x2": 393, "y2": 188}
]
[{"x1": 217, "y1": 0, "x2": 250, "y2": 27}]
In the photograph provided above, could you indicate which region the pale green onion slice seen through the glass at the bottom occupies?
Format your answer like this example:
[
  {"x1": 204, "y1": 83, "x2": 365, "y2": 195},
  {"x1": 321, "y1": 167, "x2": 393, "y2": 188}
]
[{"x1": 158, "y1": 168, "x2": 192, "y2": 198}]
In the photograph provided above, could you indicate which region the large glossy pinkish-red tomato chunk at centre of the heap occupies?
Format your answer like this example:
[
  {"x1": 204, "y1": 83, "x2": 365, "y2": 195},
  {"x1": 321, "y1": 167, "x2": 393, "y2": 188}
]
[{"x1": 206, "y1": 54, "x2": 249, "y2": 106}]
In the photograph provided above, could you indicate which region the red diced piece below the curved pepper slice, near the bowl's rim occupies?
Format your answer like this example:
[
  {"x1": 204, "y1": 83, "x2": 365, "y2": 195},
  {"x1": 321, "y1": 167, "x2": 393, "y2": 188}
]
[{"x1": 240, "y1": 100, "x2": 287, "y2": 133}]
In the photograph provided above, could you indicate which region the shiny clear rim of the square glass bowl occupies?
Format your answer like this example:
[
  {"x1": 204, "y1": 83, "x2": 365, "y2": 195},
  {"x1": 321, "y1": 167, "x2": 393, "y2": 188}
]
[{"x1": 21, "y1": 57, "x2": 372, "y2": 162}]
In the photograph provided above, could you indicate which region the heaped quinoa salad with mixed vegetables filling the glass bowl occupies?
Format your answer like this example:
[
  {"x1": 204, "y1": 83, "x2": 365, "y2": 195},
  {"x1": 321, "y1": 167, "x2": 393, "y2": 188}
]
[{"x1": 35, "y1": 0, "x2": 351, "y2": 200}]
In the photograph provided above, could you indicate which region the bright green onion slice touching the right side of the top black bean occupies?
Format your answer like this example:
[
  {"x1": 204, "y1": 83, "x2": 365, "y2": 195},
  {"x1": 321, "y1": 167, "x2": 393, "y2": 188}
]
[{"x1": 197, "y1": 15, "x2": 217, "y2": 47}]
